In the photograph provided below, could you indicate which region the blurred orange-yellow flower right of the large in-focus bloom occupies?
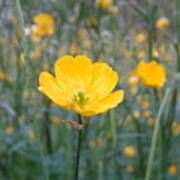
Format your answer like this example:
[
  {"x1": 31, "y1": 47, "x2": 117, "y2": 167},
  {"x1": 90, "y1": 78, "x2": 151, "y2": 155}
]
[{"x1": 135, "y1": 61, "x2": 166, "y2": 87}]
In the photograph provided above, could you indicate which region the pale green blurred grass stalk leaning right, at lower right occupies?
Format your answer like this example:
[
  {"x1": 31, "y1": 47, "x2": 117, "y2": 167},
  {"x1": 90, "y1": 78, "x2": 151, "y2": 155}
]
[{"x1": 145, "y1": 88, "x2": 171, "y2": 180}]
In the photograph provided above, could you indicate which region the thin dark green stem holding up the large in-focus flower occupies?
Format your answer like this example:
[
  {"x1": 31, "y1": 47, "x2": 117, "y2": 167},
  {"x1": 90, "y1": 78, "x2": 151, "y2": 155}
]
[{"x1": 74, "y1": 114, "x2": 82, "y2": 180}]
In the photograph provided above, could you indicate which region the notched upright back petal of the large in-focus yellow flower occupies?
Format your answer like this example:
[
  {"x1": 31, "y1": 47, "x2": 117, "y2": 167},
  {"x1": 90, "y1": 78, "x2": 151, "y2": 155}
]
[{"x1": 55, "y1": 56, "x2": 92, "y2": 93}]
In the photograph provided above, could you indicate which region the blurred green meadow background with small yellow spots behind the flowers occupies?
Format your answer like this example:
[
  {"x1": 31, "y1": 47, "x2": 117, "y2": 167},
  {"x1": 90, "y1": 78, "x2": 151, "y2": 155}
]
[{"x1": 0, "y1": 0, "x2": 180, "y2": 180}]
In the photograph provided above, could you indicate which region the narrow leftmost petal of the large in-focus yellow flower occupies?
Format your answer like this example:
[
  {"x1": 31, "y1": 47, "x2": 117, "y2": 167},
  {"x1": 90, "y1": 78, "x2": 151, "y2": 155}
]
[{"x1": 39, "y1": 72, "x2": 68, "y2": 107}]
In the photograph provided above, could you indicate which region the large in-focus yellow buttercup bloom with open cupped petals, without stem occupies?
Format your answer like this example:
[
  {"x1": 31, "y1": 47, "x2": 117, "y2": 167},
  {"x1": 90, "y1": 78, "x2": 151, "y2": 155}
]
[{"x1": 39, "y1": 56, "x2": 124, "y2": 116}]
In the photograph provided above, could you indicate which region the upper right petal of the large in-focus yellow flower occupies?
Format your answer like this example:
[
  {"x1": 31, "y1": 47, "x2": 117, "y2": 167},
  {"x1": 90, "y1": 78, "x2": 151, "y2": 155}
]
[{"x1": 89, "y1": 62, "x2": 118, "y2": 101}]
